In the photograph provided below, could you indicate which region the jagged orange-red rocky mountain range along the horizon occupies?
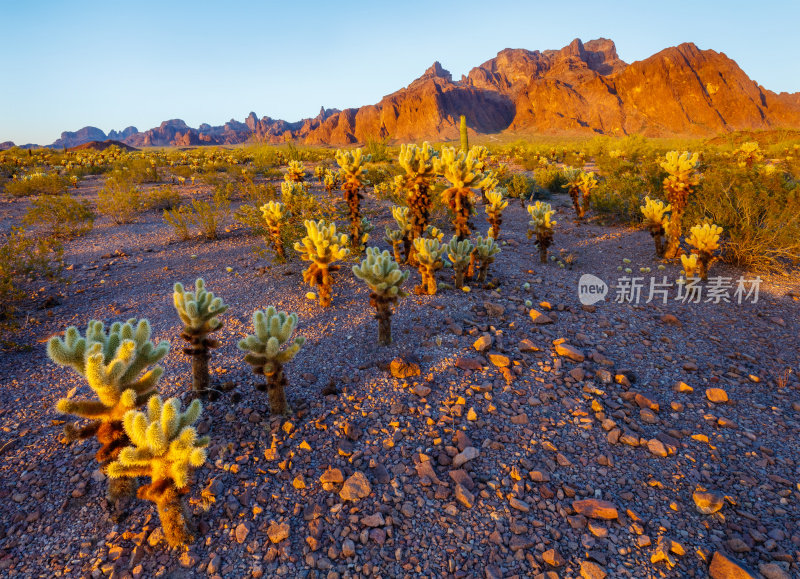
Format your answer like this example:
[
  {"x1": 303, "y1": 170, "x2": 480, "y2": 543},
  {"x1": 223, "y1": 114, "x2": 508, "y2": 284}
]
[{"x1": 17, "y1": 38, "x2": 800, "y2": 147}]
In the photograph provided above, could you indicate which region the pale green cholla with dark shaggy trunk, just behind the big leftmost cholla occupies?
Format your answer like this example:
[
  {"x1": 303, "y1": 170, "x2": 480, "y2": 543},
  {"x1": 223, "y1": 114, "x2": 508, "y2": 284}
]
[{"x1": 172, "y1": 278, "x2": 228, "y2": 396}]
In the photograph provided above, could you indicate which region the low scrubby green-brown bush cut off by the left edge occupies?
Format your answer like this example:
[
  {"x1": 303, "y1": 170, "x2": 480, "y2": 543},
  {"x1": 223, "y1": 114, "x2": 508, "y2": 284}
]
[{"x1": 0, "y1": 228, "x2": 63, "y2": 318}]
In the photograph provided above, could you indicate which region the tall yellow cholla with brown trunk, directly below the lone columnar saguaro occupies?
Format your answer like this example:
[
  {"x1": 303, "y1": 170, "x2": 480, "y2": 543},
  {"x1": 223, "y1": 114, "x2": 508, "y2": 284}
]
[{"x1": 435, "y1": 147, "x2": 484, "y2": 239}]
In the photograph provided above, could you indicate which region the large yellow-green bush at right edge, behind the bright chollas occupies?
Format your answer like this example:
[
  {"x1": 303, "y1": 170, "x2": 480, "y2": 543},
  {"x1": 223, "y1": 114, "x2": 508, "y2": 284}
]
[{"x1": 684, "y1": 162, "x2": 800, "y2": 271}]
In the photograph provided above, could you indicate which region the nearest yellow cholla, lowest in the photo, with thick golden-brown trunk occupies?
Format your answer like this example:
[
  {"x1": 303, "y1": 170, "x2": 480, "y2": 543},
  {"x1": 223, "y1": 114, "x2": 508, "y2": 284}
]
[{"x1": 108, "y1": 396, "x2": 209, "y2": 547}]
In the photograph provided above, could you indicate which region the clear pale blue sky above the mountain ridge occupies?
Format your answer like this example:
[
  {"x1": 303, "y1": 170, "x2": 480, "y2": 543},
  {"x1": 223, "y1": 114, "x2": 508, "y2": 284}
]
[{"x1": 0, "y1": 0, "x2": 800, "y2": 144}]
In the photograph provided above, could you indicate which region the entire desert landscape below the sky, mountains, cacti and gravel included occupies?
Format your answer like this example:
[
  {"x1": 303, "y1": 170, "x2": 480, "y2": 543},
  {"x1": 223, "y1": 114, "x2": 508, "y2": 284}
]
[{"x1": 0, "y1": 10, "x2": 800, "y2": 579}]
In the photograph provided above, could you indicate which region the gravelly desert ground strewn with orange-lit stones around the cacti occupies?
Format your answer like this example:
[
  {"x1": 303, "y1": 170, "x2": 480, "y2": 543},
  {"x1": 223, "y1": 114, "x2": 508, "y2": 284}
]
[{"x1": 0, "y1": 181, "x2": 800, "y2": 579}]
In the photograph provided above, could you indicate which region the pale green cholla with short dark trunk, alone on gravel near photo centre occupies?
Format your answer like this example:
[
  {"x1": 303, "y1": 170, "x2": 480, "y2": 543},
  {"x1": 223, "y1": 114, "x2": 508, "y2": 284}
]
[{"x1": 353, "y1": 247, "x2": 408, "y2": 346}]
